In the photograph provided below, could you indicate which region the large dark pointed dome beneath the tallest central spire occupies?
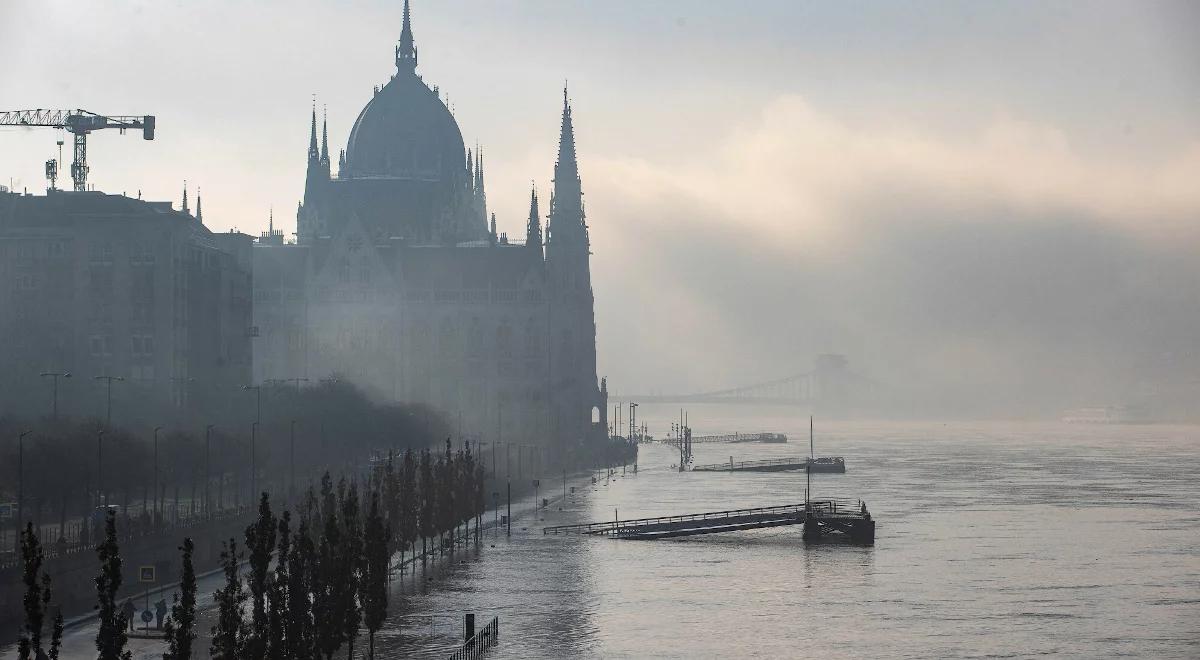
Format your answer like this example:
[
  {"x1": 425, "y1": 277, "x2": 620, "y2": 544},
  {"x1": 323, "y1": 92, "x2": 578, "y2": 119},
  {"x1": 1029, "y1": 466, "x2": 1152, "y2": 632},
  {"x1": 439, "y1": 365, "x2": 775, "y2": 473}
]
[{"x1": 341, "y1": 71, "x2": 467, "y2": 184}]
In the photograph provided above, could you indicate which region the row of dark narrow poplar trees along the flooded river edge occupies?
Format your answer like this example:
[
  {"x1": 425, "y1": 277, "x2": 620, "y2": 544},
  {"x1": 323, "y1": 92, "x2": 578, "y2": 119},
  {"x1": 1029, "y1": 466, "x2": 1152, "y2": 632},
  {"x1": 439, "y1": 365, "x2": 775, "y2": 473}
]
[{"x1": 19, "y1": 440, "x2": 484, "y2": 660}]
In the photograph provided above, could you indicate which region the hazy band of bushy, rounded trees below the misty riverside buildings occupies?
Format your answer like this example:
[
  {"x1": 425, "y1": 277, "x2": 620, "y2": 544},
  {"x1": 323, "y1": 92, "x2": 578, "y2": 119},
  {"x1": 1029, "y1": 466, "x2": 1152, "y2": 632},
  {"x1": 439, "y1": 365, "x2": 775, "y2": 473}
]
[{"x1": 0, "y1": 380, "x2": 449, "y2": 554}]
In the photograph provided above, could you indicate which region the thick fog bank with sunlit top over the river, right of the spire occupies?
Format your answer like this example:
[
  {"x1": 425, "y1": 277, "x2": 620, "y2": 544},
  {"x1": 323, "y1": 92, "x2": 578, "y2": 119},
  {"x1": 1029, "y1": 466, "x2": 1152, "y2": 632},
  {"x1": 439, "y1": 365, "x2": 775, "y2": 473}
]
[{"x1": 590, "y1": 97, "x2": 1200, "y2": 415}]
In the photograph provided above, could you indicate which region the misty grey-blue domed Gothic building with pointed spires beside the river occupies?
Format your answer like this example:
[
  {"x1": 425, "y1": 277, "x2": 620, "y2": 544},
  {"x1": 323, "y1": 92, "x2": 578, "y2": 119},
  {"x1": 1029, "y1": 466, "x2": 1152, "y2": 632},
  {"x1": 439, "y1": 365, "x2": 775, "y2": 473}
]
[{"x1": 254, "y1": 1, "x2": 607, "y2": 460}]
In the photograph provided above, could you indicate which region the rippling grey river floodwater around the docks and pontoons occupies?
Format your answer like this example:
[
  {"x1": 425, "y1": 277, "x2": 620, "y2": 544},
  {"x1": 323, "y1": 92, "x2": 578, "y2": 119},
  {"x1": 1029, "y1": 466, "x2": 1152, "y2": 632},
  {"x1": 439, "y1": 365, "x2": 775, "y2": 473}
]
[{"x1": 25, "y1": 406, "x2": 1200, "y2": 659}]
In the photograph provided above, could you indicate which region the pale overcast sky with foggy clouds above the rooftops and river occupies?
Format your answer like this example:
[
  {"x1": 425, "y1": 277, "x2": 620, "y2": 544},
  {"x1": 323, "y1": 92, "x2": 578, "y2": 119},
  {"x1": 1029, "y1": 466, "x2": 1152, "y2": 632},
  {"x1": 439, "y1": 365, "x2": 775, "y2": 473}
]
[{"x1": 0, "y1": 0, "x2": 1200, "y2": 420}]
